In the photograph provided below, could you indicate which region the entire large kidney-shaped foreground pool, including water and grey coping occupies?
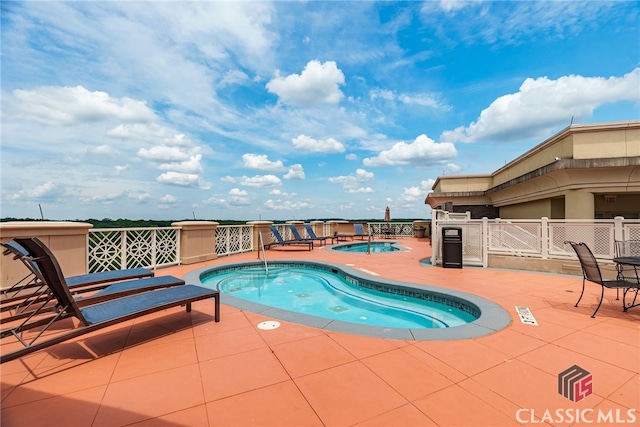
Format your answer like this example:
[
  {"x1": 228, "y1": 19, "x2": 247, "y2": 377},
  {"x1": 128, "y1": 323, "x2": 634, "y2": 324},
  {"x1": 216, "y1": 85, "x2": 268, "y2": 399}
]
[{"x1": 184, "y1": 260, "x2": 512, "y2": 341}]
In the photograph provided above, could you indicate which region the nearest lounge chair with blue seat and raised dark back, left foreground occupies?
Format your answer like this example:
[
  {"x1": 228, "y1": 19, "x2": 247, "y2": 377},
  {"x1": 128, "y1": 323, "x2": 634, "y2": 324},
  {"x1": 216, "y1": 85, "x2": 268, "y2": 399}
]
[{"x1": 0, "y1": 237, "x2": 220, "y2": 363}]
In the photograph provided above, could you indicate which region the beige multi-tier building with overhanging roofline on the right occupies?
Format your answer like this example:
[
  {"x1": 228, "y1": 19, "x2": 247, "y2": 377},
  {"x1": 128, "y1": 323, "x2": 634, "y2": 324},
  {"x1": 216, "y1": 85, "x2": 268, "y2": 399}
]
[{"x1": 425, "y1": 120, "x2": 640, "y2": 219}]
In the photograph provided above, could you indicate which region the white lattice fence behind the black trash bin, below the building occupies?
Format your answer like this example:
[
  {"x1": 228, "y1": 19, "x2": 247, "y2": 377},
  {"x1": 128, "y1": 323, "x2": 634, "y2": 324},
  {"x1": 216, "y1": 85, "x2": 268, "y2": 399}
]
[{"x1": 431, "y1": 217, "x2": 640, "y2": 267}]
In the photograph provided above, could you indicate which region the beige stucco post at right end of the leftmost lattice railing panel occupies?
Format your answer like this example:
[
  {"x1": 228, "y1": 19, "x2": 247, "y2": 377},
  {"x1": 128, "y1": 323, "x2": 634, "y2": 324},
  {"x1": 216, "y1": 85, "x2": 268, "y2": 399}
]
[{"x1": 171, "y1": 221, "x2": 218, "y2": 264}]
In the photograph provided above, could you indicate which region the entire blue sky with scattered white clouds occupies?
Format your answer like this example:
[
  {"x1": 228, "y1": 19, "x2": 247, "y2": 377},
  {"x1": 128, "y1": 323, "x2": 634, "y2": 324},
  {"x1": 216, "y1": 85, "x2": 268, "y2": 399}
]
[{"x1": 0, "y1": 0, "x2": 640, "y2": 220}]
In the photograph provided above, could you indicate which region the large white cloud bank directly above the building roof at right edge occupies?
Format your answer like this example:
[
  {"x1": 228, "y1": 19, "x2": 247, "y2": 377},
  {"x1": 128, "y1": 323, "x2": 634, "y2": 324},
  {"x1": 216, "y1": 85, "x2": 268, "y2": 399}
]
[{"x1": 441, "y1": 68, "x2": 640, "y2": 142}]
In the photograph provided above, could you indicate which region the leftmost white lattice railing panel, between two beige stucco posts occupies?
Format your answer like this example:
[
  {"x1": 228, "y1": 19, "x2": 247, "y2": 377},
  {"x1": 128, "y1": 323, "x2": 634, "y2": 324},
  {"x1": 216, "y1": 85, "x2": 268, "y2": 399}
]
[{"x1": 87, "y1": 227, "x2": 180, "y2": 273}]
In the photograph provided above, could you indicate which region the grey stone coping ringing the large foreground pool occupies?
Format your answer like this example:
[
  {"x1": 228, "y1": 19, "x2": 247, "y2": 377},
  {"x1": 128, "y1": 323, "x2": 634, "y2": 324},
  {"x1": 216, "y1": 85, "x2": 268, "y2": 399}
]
[{"x1": 184, "y1": 259, "x2": 512, "y2": 341}]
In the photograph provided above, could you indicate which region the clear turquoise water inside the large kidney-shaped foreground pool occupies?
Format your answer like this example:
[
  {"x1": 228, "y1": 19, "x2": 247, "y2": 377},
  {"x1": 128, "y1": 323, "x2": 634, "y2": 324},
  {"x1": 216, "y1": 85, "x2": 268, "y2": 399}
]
[{"x1": 202, "y1": 266, "x2": 477, "y2": 328}]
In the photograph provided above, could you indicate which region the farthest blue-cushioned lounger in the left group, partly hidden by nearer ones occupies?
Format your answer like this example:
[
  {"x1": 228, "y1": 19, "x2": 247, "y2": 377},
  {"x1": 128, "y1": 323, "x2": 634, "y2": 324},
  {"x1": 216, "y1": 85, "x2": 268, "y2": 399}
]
[{"x1": 0, "y1": 240, "x2": 154, "y2": 311}]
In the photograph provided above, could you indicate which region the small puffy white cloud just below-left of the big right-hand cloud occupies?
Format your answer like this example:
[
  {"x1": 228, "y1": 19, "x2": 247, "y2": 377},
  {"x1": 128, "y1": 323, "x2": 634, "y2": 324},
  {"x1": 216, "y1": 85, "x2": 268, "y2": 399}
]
[{"x1": 362, "y1": 134, "x2": 458, "y2": 166}]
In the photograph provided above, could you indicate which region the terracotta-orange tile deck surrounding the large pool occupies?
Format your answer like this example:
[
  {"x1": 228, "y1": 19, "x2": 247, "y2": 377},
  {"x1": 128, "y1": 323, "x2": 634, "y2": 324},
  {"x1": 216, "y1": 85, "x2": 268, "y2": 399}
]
[{"x1": 1, "y1": 238, "x2": 640, "y2": 427}]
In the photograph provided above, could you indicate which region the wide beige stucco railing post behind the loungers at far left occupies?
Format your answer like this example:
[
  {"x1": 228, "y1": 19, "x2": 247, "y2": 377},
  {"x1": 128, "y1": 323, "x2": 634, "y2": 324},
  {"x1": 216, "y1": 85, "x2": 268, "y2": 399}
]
[{"x1": 0, "y1": 221, "x2": 93, "y2": 289}]
